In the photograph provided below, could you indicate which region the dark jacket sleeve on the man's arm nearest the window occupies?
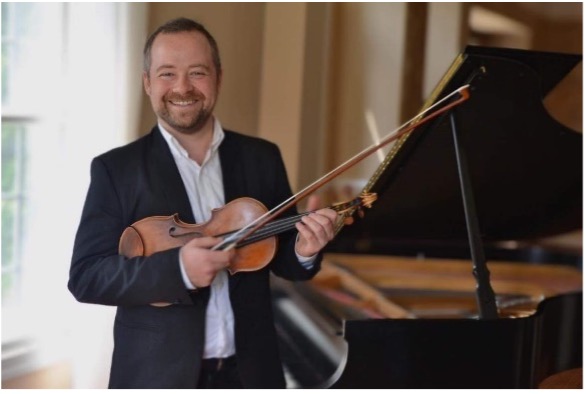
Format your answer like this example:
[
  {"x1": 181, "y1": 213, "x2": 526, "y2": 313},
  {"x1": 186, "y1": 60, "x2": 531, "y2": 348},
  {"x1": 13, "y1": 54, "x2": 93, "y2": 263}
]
[{"x1": 68, "y1": 158, "x2": 192, "y2": 306}]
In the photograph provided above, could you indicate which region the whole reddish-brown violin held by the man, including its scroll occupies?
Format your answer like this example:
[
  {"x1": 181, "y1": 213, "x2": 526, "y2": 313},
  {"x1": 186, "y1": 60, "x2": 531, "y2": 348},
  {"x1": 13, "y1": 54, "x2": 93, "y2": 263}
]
[{"x1": 118, "y1": 193, "x2": 377, "y2": 274}]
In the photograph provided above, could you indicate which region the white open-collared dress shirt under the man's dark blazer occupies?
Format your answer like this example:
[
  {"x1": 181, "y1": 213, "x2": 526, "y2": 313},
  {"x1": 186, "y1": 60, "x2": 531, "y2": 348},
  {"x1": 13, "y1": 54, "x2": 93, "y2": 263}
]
[{"x1": 159, "y1": 119, "x2": 315, "y2": 358}]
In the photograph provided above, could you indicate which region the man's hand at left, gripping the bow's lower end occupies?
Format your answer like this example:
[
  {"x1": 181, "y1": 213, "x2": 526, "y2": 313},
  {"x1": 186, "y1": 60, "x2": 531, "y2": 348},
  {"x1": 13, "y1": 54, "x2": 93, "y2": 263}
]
[{"x1": 179, "y1": 237, "x2": 236, "y2": 288}]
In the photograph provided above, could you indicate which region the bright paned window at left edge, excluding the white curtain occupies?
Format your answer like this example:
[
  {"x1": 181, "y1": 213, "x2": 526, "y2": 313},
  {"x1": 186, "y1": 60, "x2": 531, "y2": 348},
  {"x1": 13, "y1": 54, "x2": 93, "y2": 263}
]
[{"x1": 2, "y1": 3, "x2": 62, "y2": 307}]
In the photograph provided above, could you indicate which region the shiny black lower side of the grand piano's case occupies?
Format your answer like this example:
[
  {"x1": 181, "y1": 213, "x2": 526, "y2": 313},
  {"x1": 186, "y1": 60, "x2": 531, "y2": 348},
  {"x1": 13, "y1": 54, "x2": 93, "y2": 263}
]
[{"x1": 333, "y1": 292, "x2": 582, "y2": 389}]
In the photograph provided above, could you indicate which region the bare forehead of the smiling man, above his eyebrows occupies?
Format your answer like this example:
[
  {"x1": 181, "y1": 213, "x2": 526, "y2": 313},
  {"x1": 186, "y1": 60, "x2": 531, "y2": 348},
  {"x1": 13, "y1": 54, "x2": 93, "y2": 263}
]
[{"x1": 151, "y1": 31, "x2": 213, "y2": 67}]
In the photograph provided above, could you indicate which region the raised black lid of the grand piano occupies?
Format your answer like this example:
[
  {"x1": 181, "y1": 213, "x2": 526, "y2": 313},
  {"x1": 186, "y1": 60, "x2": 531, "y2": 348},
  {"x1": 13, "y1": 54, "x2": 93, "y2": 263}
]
[{"x1": 332, "y1": 46, "x2": 582, "y2": 245}]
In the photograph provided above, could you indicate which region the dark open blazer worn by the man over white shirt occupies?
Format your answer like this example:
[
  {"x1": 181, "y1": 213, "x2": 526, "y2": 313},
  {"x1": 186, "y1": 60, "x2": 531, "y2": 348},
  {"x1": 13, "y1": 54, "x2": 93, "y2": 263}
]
[{"x1": 68, "y1": 127, "x2": 321, "y2": 388}]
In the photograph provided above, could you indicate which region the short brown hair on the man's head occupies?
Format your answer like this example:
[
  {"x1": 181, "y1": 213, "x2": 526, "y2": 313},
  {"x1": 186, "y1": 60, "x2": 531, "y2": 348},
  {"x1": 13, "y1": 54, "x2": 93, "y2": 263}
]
[{"x1": 143, "y1": 18, "x2": 222, "y2": 74}]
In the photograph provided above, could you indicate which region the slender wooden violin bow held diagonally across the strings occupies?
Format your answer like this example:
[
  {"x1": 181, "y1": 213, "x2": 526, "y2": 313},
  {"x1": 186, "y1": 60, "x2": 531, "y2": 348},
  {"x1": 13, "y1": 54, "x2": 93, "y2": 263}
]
[{"x1": 212, "y1": 85, "x2": 470, "y2": 250}]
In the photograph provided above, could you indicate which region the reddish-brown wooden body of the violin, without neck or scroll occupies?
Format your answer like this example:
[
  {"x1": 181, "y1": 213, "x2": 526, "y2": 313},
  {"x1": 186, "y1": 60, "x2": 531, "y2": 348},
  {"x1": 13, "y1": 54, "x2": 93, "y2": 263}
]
[{"x1": 118, "y1": 197, "x2": 277, "y2": 274}]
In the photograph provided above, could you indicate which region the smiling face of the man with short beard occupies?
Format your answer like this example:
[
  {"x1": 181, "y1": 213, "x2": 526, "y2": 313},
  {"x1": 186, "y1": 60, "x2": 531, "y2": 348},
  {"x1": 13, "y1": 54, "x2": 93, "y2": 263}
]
[{"x1": 143, "y1": 32, "x2": 220, "y2": 134}]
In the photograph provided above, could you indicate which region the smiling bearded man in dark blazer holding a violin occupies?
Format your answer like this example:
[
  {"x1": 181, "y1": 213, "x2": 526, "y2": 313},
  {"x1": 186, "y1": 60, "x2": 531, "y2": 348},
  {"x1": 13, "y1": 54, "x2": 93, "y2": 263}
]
[{"x1": 68, "y1": 18, "x2": 336, "y2": 388}]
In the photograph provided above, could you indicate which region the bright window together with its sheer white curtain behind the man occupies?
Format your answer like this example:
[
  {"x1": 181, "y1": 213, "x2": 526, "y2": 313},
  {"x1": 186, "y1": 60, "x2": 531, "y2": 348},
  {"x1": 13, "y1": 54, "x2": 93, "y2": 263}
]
[{"x1": 1, "y1": 2, "x2": 148, "y2": 388}]
